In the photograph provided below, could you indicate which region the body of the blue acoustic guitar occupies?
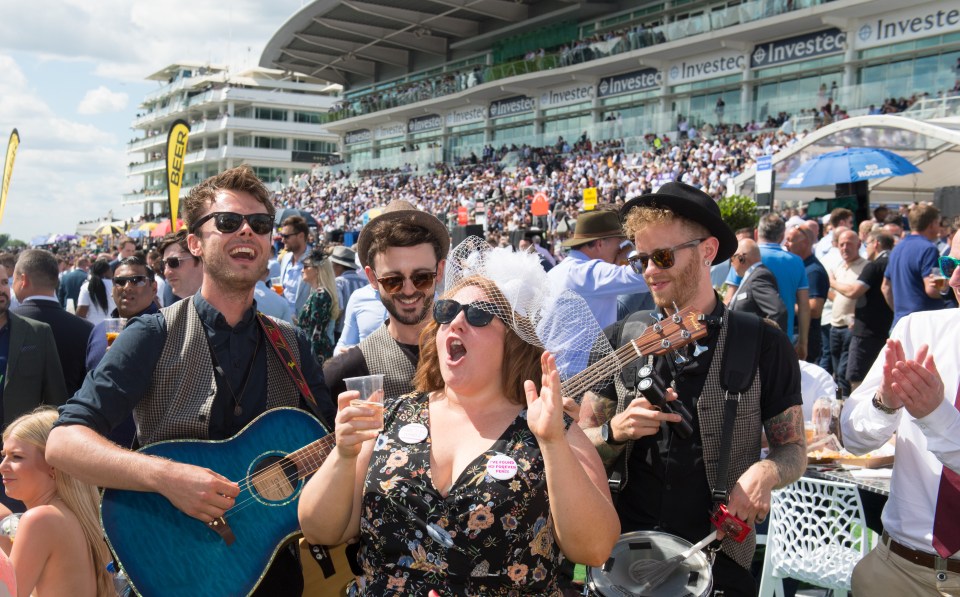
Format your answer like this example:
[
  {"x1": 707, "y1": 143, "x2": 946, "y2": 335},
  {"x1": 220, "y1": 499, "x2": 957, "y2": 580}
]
[{"x1": 100, "y1": 408, "x2": 334, "y2": 597}]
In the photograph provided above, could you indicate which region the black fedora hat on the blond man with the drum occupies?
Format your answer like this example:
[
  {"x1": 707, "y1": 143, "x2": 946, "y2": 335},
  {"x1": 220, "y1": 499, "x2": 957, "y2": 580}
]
[{"x1": 620, "y1": 182, "x2": 737, "y2": 264}]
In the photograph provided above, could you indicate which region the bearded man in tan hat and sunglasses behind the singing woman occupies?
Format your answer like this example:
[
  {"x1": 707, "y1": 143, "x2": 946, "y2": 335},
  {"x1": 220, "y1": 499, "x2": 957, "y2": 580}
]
[{"x1": 323, "y1": 200, "x2": 450, "y2": 396}]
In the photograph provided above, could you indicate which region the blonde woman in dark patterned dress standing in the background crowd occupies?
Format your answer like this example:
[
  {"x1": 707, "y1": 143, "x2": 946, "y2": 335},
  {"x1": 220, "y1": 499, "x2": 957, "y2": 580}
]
[{"x1": 297, "y1": 249, "x2": 340, "y2": 365}]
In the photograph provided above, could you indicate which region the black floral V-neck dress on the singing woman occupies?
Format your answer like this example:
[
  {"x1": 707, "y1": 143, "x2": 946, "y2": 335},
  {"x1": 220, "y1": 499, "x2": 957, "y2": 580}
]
[{"x1": 350, "y1": 393, "x2": 572, "y2": 597}]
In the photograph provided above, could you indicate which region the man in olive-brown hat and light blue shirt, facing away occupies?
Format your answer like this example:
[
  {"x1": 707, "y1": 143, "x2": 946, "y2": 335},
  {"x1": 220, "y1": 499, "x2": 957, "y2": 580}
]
[{"x1": 547, "y1": 209, "x2": 647, "y2": 327}]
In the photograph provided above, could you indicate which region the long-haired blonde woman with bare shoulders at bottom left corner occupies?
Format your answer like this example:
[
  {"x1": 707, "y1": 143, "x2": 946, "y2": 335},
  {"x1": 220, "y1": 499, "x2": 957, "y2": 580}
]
[{"x1": 0, "y1": 408, "x2": 116, "y2": 597}]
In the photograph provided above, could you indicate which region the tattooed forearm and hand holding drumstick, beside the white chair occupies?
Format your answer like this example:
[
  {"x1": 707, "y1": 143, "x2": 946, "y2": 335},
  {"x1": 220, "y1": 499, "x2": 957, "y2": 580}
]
[{"x1": 728, "y1": 406, "x2": 807, "y2": 526}]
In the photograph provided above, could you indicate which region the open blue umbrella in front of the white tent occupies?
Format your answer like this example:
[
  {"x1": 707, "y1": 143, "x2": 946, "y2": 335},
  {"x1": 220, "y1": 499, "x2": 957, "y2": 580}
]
[{"x1": 782, "y1": 147, "x2": 920, "y2": 189}]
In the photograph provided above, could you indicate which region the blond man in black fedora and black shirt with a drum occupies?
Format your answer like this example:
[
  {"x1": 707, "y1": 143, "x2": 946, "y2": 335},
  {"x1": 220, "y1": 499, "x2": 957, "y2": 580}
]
[{"x1": 580, "y1": 182, "x2": 806, "y2": 597}]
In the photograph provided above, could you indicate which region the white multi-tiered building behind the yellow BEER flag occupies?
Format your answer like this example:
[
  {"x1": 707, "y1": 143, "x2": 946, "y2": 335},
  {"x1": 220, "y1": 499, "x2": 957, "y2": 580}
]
[{"x1": 123, "y1": 63, "x2": 340, "y2": 214}]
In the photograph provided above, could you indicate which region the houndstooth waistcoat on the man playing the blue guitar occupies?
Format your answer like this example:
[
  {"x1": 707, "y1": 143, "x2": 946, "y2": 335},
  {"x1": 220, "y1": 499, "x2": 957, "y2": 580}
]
[{"x1": 133, "y1": 299, "x2": 301, "y2": 446}]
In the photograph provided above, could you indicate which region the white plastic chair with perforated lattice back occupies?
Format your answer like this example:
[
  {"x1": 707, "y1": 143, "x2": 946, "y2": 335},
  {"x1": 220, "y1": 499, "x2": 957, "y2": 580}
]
[{"x1": 760, "y1": 477, "x2": 870, "y2": 597}]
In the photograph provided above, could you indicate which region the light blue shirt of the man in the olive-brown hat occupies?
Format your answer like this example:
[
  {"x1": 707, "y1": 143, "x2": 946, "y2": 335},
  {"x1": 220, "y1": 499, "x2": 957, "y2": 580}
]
[{"x1": 547, "y1": 249, "x2": 649, "y2": 328}]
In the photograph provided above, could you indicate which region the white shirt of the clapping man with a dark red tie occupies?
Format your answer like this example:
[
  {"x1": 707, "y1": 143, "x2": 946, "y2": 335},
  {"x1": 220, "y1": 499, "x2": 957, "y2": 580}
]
[{"x1": 841, "y1": 309, "x2": 960, "y2": 559}]
